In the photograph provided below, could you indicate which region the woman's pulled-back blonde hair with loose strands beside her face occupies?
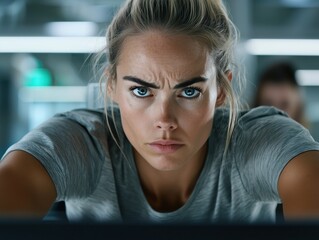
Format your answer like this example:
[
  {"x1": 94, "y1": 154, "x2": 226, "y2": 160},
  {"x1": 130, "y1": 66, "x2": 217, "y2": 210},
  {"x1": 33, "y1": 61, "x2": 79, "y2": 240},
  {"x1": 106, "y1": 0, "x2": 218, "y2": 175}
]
[{"x1": 95, "y1": 0, "x2": 239, "y2": 154}]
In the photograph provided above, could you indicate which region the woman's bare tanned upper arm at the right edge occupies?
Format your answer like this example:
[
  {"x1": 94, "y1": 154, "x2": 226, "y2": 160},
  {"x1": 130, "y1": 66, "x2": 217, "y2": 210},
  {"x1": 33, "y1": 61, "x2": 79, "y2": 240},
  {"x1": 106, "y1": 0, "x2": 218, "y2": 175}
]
[{"x1": 278, "y1": 151, "x2": 319, "y2": 221}]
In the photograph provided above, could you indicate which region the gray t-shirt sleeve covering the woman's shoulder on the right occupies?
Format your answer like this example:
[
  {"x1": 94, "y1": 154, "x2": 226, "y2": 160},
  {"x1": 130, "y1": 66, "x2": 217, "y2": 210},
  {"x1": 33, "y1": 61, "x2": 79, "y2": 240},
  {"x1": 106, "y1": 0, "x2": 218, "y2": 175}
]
[{"x1": 234, "y1": 107, "x2": 319, "y2": 201}]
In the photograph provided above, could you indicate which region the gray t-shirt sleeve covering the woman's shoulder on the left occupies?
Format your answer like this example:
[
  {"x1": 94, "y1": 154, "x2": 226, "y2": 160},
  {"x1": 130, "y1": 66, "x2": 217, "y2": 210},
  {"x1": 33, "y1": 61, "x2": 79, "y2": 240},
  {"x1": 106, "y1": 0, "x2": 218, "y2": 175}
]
[{"x1": 0, "y1": 110, "x2": 107, "y2": 200}]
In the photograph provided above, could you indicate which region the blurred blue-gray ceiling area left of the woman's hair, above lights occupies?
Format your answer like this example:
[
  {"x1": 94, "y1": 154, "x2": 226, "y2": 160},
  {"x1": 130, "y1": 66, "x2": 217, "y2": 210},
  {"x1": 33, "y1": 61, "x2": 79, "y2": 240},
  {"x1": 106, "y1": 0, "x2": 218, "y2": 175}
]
[{"x1": 0, "y1": 0, "x2": 123, "y2": 36}]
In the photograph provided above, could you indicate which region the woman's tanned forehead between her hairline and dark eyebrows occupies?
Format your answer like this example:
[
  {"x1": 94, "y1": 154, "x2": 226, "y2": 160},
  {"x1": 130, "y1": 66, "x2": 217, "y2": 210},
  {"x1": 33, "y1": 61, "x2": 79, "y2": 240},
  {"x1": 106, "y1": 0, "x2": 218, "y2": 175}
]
[{"x1": 118, "y1": 30, "x2": 211, "y2": 78}]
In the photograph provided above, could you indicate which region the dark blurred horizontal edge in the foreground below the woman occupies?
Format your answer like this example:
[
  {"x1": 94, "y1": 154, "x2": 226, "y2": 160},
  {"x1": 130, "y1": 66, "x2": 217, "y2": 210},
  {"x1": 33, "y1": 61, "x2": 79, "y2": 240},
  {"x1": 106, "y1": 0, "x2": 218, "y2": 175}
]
[{"x1": 0, "y1": 221, "x2": 319, "y2": 240}]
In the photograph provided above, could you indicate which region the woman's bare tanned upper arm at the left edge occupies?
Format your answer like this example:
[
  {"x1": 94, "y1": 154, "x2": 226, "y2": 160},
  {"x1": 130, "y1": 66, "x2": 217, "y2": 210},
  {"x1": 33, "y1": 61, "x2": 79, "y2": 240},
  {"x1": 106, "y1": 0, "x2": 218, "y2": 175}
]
[{"x1": 0, "y1": 151, "x2": 56, "y2": 218}]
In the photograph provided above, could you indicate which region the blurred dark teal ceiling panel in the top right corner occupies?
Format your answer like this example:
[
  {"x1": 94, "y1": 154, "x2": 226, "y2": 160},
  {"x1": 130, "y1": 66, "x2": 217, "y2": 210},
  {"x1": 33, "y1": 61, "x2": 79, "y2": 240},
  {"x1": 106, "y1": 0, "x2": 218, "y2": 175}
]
[{"x1": 251, "y1": 0, "x2": 319, "y2": 39}]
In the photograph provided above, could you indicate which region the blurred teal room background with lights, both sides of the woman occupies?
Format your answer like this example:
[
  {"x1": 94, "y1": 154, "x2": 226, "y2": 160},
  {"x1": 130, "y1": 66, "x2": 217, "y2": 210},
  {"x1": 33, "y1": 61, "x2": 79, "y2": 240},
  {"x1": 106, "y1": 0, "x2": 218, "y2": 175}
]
[{"x1": 0, "y1": 0, "x2": 319, "y2": 155}]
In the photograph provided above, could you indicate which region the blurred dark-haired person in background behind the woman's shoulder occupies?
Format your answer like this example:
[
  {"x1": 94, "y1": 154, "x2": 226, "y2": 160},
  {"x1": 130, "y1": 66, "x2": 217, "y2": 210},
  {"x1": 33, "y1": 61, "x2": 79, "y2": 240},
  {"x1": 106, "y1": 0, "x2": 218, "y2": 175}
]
[{"x1": 252, "y1": 62, "x2": 308, "y2": 127}]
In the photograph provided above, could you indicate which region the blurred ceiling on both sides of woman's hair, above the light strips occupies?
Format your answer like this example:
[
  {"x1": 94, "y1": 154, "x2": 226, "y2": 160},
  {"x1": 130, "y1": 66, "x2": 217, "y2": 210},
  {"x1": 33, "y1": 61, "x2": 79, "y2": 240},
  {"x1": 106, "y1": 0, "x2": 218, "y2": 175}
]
[{"x1": 0, "y1": 0, "x2": 319, "y2": 38}]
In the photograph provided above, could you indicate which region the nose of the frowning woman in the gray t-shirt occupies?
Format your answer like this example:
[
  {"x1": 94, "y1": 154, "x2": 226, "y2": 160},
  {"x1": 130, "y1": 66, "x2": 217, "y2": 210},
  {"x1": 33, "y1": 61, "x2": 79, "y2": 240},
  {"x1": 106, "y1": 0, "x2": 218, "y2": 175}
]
[{"x1": 154, "y1": 99, "x2": 178, "y2": 131}]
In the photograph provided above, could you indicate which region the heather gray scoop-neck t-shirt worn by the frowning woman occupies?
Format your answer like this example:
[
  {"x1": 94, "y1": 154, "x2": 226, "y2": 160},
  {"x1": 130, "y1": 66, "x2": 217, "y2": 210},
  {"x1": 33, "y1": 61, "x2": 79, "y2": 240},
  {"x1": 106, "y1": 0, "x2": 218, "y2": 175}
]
[{"x1": 2, "y1": 107, "x2": 319, "y2": 223}]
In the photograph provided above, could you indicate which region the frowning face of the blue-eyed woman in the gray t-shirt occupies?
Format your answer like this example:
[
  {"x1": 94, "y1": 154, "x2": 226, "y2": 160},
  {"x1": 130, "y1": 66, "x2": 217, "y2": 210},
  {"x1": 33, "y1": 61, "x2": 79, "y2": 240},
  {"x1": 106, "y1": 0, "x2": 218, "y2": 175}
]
[{"x1": 111, "y1": 31, "x2": 222, "y2": 171}]
